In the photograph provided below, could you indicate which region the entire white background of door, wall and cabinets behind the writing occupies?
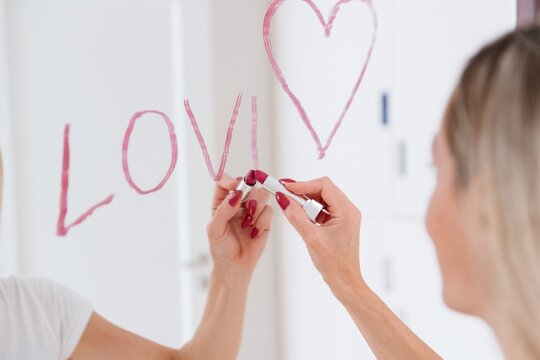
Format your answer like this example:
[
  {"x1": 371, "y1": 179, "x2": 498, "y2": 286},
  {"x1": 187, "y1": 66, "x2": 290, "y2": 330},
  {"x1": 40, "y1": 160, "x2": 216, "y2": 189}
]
[{"x1": 0, "y1": 0, "x2": 515, "y2": 360}]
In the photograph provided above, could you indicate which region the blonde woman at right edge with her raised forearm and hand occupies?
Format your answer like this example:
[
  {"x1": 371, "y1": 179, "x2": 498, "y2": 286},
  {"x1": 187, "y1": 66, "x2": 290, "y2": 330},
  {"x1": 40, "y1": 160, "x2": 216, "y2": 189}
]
[{"x1": 278, "y1": 26, "x2": 540, "y2": 359}]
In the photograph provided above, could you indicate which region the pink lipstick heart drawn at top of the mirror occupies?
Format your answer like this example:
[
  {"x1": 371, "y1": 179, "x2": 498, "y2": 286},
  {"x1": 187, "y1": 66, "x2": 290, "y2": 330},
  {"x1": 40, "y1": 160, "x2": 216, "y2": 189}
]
[{"x1": 263, "y1": 0, "x2": 377, "y2": 159}]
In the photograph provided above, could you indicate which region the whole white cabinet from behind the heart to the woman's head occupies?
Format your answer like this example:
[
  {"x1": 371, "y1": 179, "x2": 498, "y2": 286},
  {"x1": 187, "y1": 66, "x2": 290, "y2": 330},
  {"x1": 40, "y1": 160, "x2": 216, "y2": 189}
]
[{"x1": 274, "y1": 0, "x2": 515, "y2": 360}]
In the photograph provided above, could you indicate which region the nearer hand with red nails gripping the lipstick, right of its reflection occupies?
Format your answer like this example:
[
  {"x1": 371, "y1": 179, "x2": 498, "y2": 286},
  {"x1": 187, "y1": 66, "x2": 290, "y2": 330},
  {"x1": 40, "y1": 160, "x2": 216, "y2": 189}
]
[{"x1": 276, "y1": 178, "x2": 363, "y2": 295}]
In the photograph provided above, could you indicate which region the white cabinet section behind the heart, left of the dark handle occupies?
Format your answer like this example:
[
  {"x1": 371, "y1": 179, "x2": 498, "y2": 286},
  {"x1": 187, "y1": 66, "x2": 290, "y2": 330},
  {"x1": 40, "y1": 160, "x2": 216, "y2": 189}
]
[{"x1": 272, "y1": 1, "x2": 396, "y2": 360}]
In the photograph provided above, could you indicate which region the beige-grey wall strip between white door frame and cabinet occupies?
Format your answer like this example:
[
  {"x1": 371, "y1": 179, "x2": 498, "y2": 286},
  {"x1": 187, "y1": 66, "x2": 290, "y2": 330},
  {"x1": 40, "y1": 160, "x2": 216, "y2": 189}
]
[{"x1": 212, "y1": 0, "x2": 280, "y2": 360}]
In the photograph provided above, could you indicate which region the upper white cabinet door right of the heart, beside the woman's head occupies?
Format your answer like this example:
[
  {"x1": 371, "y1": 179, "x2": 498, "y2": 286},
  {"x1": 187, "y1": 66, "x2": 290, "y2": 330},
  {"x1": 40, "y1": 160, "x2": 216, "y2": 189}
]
[{"x1": 392, "y1": 0, "x2": 516, "y2": 218}]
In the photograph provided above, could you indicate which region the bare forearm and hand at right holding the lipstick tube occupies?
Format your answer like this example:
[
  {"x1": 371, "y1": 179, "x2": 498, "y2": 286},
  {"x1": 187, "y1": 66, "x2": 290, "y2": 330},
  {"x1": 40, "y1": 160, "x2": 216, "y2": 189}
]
[{"x1": 278, "y1": 178, "x2": 440, "y2": 359}]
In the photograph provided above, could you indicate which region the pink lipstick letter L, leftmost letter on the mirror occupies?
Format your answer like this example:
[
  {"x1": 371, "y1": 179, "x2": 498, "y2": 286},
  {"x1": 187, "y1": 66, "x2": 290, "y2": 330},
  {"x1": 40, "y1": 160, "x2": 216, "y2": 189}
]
[{"x1": 56, "y1": 124, "x2": 114, "y2": 236}]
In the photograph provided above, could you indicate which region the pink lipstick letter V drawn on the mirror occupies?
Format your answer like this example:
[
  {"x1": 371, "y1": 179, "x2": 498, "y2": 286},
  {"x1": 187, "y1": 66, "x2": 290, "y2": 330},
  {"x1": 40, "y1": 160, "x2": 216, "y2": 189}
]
[{"x1": 184, "y1": 94, "x2": 242, "y2": 182}]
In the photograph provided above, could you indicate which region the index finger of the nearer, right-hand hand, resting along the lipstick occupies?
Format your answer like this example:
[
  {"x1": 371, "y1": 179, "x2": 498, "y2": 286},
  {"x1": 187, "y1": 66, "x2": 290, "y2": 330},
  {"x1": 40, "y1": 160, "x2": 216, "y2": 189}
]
[{"x1": 283, "y1": 177, "x2": 351, "y2": 215}]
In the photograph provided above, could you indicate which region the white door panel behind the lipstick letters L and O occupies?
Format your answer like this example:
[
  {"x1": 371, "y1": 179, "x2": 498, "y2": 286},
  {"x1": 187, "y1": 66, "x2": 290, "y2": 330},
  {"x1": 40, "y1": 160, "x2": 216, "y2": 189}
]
[{"x1": 6, "y1": 0, "x2": 182, "y2": 345}]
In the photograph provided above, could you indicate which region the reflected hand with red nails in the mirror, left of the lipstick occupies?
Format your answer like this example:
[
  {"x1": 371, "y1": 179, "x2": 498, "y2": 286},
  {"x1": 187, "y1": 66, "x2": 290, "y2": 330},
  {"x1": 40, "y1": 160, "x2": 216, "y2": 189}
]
[{"x1": 207, "y1": 175, "x2": 272, "y2": 274}]
